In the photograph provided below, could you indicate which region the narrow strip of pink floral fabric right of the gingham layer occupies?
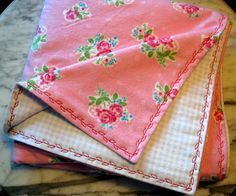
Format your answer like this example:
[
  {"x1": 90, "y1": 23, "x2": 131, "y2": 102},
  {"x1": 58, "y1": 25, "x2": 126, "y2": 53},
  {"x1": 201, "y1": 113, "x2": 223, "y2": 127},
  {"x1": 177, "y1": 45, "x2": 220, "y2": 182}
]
[{"x1": 200, "y1": 49, "x2": 229, "y2": 181}]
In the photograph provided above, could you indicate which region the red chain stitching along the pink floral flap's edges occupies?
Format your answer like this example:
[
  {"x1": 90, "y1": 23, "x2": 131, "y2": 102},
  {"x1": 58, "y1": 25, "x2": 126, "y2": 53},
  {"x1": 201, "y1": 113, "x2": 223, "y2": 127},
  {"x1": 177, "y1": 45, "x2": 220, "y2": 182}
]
[{"x1": 19, "y1": 15, "x2": 226, "y2": 162}]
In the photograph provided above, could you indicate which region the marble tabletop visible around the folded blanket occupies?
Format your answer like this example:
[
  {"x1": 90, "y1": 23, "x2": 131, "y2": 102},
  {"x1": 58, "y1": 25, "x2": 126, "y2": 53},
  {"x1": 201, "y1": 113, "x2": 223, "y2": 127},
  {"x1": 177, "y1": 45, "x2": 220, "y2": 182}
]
[{"x1": 0, "y1": 0, "x2": 236, "y2": 196}]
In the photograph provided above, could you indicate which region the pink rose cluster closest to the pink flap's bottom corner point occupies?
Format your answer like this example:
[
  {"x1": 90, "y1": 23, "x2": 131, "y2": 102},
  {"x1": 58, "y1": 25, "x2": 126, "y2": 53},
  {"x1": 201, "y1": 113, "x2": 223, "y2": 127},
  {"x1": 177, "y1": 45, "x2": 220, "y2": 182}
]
[{"x1": 88, "y1": 88, "x2": 133, "y2": 129}]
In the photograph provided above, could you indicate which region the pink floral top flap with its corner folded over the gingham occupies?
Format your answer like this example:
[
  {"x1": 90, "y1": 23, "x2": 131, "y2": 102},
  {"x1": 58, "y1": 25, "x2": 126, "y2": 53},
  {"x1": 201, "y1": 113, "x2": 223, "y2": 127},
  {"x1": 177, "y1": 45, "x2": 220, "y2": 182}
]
[{"x1": 19, "y1": 0, "x2": 227, "y2": 162}]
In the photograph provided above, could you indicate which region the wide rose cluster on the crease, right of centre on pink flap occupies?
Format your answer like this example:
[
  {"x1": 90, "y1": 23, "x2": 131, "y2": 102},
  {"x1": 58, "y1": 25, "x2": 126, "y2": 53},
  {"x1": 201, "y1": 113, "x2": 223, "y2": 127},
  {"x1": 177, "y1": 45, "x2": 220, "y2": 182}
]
[{"x1": 132, "y1": 24, "x2": 178, "y2": 67}]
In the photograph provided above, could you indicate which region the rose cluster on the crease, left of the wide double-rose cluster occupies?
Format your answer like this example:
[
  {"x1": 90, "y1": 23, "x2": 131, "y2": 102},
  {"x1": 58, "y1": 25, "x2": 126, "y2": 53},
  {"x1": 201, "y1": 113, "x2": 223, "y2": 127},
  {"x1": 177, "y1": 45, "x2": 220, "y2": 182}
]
[{"x1": 76, "y1": 33, "x2": 118, "y2": 67}]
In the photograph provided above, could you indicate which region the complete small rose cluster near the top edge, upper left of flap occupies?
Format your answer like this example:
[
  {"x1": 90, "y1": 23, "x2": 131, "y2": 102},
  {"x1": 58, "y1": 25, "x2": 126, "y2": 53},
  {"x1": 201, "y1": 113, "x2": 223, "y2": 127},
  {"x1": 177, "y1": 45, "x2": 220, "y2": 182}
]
[{"x1": 63, "y1": 1, "x2": 92, "y2": 22}]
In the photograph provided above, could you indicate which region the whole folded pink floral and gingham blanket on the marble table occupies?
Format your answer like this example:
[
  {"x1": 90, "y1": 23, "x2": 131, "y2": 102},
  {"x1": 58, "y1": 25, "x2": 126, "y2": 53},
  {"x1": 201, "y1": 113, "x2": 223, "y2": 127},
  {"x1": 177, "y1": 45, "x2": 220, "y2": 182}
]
[{"x1": 5, "y1": 0, "x2": 230, "y2": 194}]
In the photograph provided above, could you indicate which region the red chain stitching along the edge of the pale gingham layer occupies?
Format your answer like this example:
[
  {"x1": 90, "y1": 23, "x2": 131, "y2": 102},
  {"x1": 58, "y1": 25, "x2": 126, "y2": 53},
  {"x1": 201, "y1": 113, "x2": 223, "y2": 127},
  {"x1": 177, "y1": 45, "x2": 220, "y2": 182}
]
[{"x1": 7, "y1": 28, "x2": 223, "y2": 191}]
